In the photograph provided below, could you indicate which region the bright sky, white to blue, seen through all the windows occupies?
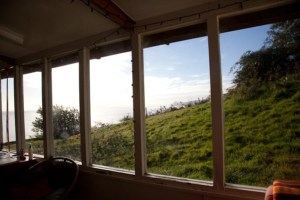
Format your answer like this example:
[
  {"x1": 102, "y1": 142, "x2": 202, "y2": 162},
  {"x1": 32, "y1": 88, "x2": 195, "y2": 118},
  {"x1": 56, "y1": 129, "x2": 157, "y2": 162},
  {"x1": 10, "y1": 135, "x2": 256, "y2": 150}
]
[{"x1": 2, "y1": 25, "x2": 270, "y2": 139}]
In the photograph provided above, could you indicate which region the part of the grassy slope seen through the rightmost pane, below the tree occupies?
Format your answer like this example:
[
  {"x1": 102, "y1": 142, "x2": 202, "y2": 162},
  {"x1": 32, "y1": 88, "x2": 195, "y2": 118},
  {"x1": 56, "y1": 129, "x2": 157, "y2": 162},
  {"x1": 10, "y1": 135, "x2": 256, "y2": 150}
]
[{"x1": 225, "y1": 85, "x2": 300, "y2": 186}]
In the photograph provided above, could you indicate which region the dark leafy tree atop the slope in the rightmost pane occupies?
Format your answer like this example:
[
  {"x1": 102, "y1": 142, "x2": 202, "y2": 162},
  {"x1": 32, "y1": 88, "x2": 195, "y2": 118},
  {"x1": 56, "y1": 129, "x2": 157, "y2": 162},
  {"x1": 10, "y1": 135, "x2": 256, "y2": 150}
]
[{"x1": 231, "y1": 19, "x2": 300, "y2": 96}]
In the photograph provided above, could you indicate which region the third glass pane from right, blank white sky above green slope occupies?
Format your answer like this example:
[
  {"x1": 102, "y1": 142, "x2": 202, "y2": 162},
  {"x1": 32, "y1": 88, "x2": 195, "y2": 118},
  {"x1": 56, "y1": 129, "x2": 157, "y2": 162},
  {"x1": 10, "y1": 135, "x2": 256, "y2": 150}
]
[{"x1": 90, "y1": 52, "x2": 134, "y2": 170}]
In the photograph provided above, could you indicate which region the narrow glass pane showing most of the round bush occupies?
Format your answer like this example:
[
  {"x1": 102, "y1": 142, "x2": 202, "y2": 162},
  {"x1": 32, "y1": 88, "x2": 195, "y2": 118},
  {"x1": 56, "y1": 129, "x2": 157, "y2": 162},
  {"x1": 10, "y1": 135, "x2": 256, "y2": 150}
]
[{"x1": 52, "y1": 63, "x2": 81, "y2": 161}]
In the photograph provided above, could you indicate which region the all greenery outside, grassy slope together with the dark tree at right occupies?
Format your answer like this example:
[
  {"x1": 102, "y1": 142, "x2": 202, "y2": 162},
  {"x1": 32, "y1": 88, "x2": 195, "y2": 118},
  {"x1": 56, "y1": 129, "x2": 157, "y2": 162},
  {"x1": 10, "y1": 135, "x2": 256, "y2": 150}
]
[{"x1": 24, "y1": 20, "x2": 300, "y2": 186}]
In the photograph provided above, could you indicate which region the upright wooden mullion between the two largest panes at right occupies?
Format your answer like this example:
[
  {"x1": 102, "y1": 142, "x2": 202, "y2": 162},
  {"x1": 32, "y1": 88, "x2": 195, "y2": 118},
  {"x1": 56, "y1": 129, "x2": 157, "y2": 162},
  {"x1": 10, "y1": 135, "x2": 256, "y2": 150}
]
[{"x1": 207, "y1": 16, "x2": 225, "y2": 190}]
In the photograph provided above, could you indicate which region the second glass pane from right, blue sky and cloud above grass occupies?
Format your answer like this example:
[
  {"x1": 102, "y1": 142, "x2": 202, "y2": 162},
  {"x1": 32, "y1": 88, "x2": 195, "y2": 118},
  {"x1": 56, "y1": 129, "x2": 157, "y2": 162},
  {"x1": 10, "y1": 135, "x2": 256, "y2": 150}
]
[{"x1": 144, "y1": 37, "x2": 213, "y2": 180}]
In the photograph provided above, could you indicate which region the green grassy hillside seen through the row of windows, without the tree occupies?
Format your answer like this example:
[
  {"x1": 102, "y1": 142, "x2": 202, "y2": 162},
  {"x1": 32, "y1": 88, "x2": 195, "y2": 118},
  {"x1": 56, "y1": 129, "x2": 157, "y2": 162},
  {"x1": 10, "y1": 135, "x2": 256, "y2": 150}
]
[{"x1": 26, "y1": 82, "x2": 300, "y2": 186}]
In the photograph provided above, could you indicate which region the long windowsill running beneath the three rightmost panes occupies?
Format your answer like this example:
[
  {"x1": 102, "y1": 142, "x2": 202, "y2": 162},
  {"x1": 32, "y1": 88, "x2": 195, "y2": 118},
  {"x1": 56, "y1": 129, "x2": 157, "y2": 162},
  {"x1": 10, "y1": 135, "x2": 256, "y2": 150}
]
[{"x1": 80, "y1": 165, "x2": 266, "y2": 199}]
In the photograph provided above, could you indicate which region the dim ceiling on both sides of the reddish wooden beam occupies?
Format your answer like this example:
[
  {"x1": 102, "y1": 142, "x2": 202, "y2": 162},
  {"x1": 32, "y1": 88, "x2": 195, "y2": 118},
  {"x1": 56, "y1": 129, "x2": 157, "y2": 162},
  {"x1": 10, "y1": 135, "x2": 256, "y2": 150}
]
[{"x1": 0, "y1": 0, "x2": 296, "y2": 64}]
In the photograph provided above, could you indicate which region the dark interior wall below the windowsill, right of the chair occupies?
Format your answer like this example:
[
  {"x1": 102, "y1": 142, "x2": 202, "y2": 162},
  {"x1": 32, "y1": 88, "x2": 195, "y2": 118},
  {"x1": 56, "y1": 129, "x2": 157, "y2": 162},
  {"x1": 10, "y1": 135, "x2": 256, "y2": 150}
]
[{"x1": 71, "y1": 171, "x2": 260, "y2": 200}]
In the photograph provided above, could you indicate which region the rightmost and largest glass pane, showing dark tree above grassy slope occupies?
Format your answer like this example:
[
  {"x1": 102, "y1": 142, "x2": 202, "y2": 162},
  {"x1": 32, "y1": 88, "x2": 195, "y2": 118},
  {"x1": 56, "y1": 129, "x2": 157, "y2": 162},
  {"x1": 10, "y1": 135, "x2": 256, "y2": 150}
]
[{"x1": 221, "y1": 20, "x2": 300, "y2": 187}]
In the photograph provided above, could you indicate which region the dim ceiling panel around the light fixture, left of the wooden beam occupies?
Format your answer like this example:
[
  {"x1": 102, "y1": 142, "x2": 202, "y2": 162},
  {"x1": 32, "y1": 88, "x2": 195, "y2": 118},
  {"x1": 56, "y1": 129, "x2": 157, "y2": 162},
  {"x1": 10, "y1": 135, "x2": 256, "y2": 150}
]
[{"x1": 0, "y1": 0, "x2": 118, "y2": 58}]
